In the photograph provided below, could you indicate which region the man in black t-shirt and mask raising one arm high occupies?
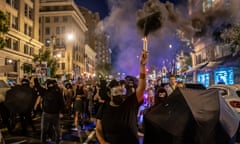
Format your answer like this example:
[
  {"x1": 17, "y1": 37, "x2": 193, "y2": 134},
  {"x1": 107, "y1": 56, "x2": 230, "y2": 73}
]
[{"x1": 96, "y1": 51, "x2": 148, "y2": 144}]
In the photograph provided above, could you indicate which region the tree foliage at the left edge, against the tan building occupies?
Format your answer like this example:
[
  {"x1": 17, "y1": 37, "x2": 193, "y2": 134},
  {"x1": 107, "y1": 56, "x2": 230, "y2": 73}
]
[{"x1": 0, "y1": 10, "x2": 9, "y2": 49}]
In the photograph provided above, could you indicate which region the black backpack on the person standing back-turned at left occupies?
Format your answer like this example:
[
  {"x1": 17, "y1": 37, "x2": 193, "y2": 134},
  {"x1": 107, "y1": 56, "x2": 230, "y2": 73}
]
[{"x1": 42, "y1": 90, "x2": 62, "y2": 114}]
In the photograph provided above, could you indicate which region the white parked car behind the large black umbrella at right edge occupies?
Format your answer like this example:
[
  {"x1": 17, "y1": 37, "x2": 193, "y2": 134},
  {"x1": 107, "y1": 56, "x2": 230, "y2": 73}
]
[{"x1": 208, "y1": 84, "x2": 240, "y2": 118}]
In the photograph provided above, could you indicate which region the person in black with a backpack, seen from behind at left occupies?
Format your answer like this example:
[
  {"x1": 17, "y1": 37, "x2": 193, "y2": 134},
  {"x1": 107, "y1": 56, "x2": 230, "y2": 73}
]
[{"x1": 41, "y1": 80, "x2": 64, "y2": 144}]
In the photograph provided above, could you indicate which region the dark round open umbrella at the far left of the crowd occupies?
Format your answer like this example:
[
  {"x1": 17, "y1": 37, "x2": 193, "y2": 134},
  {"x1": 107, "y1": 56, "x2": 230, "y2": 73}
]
[{"x1": 4, "y1": 85, "x2": 34, "y2": 113}]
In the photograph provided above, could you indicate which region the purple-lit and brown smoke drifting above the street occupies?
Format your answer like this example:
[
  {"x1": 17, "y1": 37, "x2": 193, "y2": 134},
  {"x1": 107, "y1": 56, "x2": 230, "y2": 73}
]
[{"x1": 98, "y1": 0, "x2": 240, "y2": 75}]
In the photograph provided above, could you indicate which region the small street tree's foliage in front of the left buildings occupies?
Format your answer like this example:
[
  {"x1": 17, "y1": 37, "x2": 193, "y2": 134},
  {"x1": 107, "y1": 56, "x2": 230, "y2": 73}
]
[{"x1": 33, "y1": 50, "x2": 57, "y2": 77}]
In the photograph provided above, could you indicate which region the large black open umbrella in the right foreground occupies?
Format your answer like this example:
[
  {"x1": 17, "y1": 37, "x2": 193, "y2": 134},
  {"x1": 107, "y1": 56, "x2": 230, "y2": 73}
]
[{"x1": 144, "y1": 88, "x2": 239, "y2": 144}]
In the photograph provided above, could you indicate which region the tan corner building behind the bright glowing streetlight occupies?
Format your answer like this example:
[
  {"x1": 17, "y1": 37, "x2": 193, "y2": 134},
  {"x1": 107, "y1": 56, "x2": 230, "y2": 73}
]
[{"x1": 39, "y1": 0, "x2": 88, "y2": 79}]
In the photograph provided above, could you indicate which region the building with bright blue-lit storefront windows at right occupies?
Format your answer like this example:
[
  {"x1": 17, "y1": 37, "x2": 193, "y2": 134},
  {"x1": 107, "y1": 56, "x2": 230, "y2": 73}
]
[{"x1": 187, "y1": 0, "x2": 237, "y2": 86}]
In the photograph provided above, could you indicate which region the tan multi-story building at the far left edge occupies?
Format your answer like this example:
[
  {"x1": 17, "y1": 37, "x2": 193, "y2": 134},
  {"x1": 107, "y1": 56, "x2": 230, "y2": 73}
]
[{"x1": 0, "y1": 0, "x2": 43, "y2": 82}]
